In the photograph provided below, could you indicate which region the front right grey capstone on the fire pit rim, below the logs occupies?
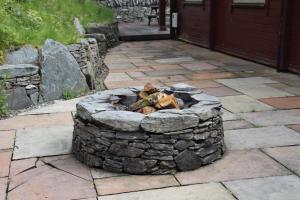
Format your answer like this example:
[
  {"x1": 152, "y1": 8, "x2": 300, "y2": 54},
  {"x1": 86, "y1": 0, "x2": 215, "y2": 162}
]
[{"x1": 141, "y1": 110, "x2": 199, "y2": 133}]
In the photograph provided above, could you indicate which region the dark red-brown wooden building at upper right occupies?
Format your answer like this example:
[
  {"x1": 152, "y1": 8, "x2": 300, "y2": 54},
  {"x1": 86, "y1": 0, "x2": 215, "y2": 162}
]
[{"x1": 171, "y1": 0, "x2": 300, "y2": 72}]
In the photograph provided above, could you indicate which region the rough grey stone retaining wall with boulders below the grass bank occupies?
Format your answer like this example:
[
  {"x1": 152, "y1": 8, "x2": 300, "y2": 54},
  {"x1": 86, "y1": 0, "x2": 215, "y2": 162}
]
[{"x1": 0, "y1": 18, "x2": 115, "y2": 110}]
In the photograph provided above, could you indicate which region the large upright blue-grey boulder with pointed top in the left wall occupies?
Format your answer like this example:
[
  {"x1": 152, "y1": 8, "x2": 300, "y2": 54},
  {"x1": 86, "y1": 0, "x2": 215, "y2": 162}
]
[{"x1": 40, "y1": 39, "x2": 88, "y2": 101}]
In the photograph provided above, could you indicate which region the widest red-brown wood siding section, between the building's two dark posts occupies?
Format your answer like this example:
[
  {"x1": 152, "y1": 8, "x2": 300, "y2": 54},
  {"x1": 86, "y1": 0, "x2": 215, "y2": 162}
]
[{"x1": 214, "y1": 0, "x2": 280, "y2": 66}]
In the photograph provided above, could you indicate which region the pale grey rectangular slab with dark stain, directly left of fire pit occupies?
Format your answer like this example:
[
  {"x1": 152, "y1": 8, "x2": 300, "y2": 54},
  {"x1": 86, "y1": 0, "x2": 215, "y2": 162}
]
[{"x1": 13, "y1": 126, "x2": 73, "y2": 159}]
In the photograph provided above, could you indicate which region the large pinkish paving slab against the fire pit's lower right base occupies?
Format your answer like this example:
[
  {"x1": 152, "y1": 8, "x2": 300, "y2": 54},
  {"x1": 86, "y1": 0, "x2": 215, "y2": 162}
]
[{"x1": 175, "y1": 150, "x2": 291, "y2": 185}]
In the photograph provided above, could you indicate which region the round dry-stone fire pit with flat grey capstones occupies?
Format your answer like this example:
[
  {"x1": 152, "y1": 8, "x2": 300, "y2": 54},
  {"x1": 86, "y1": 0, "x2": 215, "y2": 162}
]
[{"x1": 73, "y1": 84, "x2": 225, "y2": 174}]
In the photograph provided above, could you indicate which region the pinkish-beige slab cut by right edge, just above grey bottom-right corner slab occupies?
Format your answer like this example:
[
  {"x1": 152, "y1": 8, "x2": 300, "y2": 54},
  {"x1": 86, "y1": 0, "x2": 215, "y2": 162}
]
[{"x1": 263, "y1": 146, "x2": 300, "y2": 176}]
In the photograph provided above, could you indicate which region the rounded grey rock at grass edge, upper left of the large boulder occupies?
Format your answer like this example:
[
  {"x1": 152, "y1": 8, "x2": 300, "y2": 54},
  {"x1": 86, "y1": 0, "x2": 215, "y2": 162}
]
[{"x1": 6, "y1": 46, "x2": 39, "y2": 65}]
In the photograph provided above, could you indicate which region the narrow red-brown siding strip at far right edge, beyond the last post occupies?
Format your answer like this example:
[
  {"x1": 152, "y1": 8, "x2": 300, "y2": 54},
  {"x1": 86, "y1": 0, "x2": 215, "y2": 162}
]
[{"x1": 287, "y1": 0, "x2": 300, "y2": 72}]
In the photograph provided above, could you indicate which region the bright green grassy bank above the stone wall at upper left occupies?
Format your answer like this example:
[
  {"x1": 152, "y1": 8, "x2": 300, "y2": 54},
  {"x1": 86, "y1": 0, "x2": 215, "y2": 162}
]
[{"x1": 0, "y1": 0, "x2": 113, "y2": 63}]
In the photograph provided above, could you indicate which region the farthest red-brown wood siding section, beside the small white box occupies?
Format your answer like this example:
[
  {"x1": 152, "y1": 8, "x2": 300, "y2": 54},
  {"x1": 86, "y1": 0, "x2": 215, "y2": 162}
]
[{"x1": 177, "y1": 0, "x2": 210, "y2": 47}]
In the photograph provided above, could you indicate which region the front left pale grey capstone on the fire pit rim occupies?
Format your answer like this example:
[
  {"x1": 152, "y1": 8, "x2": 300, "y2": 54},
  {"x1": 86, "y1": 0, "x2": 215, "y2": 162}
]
[{"x1": 92, "y1": 111, "x2": 145, "y2": 131}]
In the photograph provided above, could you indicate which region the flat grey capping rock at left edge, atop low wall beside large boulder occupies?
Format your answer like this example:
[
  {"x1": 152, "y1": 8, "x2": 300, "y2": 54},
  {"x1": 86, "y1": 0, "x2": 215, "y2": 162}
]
[{"x1": 0, "y1": 64, "x2": 39, "y2": 78}]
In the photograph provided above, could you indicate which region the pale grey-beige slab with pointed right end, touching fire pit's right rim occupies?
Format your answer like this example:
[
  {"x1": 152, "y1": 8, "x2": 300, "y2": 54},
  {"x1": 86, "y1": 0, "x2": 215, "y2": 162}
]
[{"x1": 220, "y1": 95, "x2": 274, "y2": 113}]
